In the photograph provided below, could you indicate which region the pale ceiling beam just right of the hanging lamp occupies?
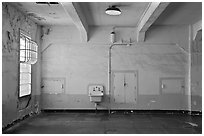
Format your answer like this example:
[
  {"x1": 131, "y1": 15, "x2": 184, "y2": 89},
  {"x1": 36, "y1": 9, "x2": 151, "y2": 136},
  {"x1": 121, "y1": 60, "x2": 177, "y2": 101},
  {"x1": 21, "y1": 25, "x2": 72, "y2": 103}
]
[{"x1": 137, "y1": 2, "x2": 169, "y2": 42}]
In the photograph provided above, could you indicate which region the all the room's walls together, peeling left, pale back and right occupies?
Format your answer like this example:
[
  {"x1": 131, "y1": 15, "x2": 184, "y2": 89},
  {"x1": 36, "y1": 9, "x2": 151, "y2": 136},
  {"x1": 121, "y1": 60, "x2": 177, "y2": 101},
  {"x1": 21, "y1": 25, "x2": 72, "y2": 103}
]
[{"x1": 2, "y1": 3, "x2": 202, "y2": 129}]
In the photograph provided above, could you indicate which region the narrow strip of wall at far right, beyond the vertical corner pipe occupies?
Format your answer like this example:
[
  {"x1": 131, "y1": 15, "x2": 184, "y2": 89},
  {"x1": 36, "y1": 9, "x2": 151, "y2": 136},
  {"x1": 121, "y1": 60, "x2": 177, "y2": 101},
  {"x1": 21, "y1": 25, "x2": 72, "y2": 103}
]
[{"x1": 191, "y1": 28, "x2": 202, "y2": 111}]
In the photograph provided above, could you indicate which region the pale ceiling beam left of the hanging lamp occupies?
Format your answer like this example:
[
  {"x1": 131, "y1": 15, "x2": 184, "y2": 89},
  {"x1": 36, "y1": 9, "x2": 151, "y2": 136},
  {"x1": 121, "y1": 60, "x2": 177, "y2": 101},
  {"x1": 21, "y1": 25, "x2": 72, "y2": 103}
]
[{"x1": 61, "y1": 2, "x2": 88, "y2": 42}]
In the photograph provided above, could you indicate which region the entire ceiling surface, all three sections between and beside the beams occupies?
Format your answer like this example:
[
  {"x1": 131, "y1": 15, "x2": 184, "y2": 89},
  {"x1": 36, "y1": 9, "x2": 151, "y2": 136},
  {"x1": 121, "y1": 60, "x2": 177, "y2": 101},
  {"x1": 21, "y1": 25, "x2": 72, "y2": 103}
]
[{"x1": 11, "y1": 2, "x2": 202, "y2": 26}]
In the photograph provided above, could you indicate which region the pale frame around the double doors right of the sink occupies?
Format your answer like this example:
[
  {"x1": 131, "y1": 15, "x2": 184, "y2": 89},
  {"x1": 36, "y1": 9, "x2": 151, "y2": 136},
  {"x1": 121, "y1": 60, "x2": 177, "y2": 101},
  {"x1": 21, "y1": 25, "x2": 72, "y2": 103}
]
[{"x1": 110, "y1": 70, "x2": 139, "y2": 104}]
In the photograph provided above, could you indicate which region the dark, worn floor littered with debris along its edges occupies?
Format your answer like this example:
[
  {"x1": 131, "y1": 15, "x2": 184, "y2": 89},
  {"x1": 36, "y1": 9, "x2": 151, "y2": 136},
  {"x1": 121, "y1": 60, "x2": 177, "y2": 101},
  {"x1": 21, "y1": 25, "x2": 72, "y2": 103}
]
[{"x1": 3, "y1": 112, "x2": 202, "y2": 134}]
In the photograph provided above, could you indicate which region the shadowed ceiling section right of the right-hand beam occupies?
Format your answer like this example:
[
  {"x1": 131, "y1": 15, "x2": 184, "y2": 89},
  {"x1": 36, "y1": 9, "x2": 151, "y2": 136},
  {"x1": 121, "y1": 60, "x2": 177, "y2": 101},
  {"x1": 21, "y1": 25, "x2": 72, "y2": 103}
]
[{"x1": 154, "y1": 2, "x2": 202, "y2": 25}]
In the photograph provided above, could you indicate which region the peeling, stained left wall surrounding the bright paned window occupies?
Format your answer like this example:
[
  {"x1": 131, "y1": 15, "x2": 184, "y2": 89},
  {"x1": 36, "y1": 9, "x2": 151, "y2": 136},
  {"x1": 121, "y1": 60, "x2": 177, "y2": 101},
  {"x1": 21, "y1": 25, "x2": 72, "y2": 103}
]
[{"x1": 2, "y1": 3, "x2": 41, "y2": 127}]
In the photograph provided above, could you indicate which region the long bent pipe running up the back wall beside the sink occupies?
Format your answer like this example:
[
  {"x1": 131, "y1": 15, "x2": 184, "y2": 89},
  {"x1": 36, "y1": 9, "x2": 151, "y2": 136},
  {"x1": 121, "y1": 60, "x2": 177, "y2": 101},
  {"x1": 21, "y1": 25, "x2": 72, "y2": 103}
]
[{"x1": 108, "y1": 43, "x2": 134, "y2": 114}]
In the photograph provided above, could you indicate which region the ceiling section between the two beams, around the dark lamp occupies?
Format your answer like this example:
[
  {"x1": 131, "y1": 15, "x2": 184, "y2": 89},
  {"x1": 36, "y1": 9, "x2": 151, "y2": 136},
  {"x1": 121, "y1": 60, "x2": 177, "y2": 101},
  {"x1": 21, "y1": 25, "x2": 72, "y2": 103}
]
[{"x1": 81, "y1": 2, "x2": 149, "y2": 26}]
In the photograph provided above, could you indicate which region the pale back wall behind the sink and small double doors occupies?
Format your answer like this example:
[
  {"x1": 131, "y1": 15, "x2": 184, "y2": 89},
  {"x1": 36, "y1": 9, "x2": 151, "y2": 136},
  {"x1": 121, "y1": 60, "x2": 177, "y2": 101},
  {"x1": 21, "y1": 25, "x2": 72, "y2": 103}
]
[{"x1": 42, "y1": 26, "x2": 190, "y2": 110}]
